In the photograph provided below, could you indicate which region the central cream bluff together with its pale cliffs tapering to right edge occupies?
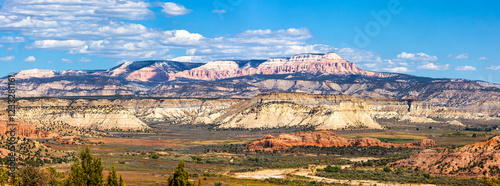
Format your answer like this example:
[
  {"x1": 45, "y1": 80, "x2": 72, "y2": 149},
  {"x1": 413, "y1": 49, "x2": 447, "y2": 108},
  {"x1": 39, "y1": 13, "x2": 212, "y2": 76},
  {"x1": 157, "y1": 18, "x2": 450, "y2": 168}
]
[{"x1": 215, "y1": 93, "x2": 500, "y2": 130}]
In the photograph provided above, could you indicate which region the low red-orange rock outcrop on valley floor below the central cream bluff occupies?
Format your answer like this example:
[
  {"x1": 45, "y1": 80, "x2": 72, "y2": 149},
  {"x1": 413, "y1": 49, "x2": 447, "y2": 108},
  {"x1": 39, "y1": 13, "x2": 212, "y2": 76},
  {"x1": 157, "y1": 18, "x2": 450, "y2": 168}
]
[{"x1": 248, "y1": 131, "x2": 435, "y2": 151}]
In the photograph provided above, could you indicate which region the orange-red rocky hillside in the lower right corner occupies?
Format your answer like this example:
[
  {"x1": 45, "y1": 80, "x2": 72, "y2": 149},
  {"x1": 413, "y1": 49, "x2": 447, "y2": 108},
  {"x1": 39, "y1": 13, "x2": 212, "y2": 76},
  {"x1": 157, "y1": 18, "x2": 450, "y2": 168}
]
[{"x1": 391, "y1": 136, "x2": 500, "y2": 177}]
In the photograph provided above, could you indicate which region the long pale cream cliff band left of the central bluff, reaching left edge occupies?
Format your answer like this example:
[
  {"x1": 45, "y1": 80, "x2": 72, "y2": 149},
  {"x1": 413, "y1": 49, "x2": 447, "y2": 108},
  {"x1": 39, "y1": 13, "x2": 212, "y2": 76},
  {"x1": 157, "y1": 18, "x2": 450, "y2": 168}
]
[{"x1": 0, "y1": 98, "x2": 241, "y2": 129}]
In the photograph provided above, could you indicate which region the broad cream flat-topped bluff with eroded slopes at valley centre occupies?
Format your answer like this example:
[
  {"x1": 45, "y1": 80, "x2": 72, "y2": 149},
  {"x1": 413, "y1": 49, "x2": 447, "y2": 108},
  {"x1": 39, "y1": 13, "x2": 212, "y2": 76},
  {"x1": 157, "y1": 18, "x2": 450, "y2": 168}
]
[{"x1": 216, "y1": 93, "x2": 382, "y2": 130}]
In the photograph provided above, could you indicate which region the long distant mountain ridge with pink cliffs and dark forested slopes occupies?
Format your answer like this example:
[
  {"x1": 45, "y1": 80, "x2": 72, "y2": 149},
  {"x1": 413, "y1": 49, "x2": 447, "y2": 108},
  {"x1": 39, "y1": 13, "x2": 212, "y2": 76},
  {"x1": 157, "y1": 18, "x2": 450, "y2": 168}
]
[{"x1": 0, "y1": 53, "x2": 500, "y2": 107}]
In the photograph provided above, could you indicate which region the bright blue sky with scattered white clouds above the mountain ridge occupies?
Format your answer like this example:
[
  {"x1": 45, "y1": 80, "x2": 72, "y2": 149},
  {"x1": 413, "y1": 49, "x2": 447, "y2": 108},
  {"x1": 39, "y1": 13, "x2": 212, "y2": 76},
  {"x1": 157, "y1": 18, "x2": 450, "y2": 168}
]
[{"x1": 0, "y1": 0, "x2": 500, "y2": 83}]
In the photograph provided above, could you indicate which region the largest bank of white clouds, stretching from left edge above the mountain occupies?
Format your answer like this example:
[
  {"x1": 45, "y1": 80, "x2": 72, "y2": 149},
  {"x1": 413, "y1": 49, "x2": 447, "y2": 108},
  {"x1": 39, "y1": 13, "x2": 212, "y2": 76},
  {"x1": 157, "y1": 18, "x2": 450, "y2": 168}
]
[{"x1": 0, "y1": 0, "x2": 370, "y2": 62}]
